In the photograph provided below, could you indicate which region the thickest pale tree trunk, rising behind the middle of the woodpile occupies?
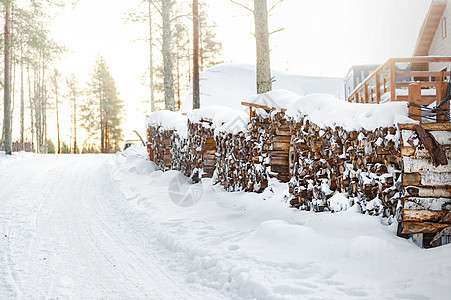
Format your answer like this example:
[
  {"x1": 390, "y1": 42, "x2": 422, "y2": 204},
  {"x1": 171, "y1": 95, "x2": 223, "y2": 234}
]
[{"x1": 254, "y1": 0, "x2": 272, "y2": 94}]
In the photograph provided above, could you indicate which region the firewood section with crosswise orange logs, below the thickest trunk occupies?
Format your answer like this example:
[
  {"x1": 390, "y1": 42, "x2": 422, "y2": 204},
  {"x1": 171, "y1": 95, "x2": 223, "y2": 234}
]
[{"x1": 250, "y1": 108, "x2": 291, "y2": 182}]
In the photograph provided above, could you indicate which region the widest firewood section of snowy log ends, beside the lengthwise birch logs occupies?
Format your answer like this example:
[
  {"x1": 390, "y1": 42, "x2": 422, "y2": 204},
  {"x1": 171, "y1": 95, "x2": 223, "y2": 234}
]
[{"x1": 289, "y1": 118, "x2": 402, "y2": 216}]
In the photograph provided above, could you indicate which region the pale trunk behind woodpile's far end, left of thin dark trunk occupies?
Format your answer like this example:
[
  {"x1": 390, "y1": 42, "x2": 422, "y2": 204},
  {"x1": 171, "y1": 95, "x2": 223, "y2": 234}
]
[{"x1": 161, "y1": 0, "x2": 175, "y2": 111}]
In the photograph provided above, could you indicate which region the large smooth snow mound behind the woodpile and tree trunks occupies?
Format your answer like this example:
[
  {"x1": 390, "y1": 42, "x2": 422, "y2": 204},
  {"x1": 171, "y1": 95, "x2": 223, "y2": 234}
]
[{"x1": 180, "y1": 63, "x2": 344, "y2": 112}]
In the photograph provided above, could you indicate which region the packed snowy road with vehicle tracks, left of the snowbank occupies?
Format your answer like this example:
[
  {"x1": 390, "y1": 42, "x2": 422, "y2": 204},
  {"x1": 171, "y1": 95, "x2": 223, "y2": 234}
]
[{"x1": 0, "y1": 155, "x2": 219, "y2": 299}]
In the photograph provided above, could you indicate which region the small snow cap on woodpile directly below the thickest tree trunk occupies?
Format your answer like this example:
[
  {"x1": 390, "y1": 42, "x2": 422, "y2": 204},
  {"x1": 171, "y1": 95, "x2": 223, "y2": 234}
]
[{"x1": 245, "y1": 89, "x2": 299, "y2": 111}]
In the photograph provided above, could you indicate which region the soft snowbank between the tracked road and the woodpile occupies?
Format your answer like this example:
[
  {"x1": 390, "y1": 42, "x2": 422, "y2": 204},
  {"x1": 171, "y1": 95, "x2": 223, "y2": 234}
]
[{"x1": 113, "y1": 150, "x2": 451, "y2": 299}]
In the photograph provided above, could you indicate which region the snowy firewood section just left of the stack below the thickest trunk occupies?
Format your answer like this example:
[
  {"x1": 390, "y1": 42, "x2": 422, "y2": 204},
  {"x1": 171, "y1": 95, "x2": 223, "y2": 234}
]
[{"x1": 215, "y1": 119, "x2": 268, "y2": 192}]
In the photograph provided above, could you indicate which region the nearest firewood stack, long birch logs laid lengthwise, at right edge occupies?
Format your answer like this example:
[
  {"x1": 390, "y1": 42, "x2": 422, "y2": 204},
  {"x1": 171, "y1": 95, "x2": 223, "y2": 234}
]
[{"x1": 398, "y1": 122, "x2": 451, "y2": 247}]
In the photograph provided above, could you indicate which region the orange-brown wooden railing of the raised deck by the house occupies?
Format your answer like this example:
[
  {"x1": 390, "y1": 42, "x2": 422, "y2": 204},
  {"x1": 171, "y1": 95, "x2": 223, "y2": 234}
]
[{"x1": 348, "y1": 56, "x2": 451, "y2": 119}]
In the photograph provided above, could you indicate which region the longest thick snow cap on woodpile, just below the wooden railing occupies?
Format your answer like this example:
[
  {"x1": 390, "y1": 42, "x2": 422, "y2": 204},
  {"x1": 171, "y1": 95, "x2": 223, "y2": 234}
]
[{"x1": 285, "y1": 94, "x2": 416, "y2": 130}]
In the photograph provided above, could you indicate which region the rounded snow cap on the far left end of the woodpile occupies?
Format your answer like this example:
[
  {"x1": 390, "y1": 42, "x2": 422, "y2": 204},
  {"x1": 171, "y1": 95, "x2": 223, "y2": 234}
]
[{"x1": 147, "y1": 110, "x2": 188, "y2": 137}]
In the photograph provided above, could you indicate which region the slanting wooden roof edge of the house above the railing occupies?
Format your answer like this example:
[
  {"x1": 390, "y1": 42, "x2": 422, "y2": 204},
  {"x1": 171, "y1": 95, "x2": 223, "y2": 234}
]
[{"x1": 413, "y1": 0, "x2": 446, "y2": 56}]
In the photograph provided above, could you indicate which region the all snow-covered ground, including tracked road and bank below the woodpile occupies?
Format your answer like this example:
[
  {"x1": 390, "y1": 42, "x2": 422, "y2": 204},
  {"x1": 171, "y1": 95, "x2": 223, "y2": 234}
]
[{"x1": 0, "y1": 148, "x2": 451, "y2": 299}]
